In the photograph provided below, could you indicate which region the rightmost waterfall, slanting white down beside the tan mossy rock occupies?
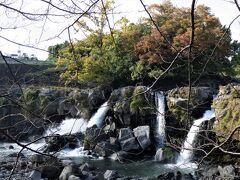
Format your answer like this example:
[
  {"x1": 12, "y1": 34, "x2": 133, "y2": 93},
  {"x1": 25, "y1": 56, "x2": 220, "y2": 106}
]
[{"x1": 177, "y1": 110, "x2": 215, "y2": 165}]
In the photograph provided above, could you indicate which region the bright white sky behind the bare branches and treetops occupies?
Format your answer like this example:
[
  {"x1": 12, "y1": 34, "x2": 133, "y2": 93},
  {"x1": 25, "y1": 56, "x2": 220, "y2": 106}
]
[{"x1": 0, "y1": 0, "x2": 240, "y2": 60}]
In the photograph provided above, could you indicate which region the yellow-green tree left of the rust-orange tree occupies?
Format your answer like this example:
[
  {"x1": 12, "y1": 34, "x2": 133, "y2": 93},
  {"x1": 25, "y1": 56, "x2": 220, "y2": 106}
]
[{"x1": 57, "y1": 12, "x2": 150, "y2": 84}]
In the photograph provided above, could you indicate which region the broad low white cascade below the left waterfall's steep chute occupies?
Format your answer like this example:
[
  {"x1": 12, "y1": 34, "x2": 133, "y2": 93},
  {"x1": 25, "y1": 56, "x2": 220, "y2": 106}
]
[{"x1": 46, "y1": 118, "x2": 87, "y2": 135}]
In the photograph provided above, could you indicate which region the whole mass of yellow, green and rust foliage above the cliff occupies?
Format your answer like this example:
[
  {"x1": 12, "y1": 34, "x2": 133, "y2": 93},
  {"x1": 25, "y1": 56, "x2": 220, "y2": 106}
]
[{"x1": 49, "y1": 1, "x2": 233, "y2": 86}]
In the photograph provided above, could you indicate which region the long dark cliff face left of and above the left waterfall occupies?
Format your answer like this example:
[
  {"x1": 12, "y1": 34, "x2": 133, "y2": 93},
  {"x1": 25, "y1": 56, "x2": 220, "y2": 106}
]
[{"x1": 0, "y1": 86, "x2": 111, "y2": 139}]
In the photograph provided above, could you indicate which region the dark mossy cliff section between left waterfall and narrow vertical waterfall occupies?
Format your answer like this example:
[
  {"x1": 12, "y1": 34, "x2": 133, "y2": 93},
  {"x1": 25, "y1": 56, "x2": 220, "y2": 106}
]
[{"x1": 109, "y1": 86, "x2": 156, "y2": 128}]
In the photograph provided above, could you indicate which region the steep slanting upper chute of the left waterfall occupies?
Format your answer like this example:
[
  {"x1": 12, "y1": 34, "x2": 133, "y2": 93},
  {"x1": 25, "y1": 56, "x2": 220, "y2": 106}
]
[{"x1": 87, "y1": 102, "x2": 109, "y2": 128}]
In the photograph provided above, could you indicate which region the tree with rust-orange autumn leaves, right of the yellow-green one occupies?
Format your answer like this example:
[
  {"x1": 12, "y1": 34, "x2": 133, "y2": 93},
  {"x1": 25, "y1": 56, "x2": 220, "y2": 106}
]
[{"x1": 135, "y1": 1, "x2": 231, "y2": 78}]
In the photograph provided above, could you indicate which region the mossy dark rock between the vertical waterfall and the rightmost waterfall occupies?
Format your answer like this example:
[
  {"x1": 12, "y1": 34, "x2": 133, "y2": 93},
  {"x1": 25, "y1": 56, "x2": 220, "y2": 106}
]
[{"x1": 167, "y1": 87, "x2": 216, "y2": 127}]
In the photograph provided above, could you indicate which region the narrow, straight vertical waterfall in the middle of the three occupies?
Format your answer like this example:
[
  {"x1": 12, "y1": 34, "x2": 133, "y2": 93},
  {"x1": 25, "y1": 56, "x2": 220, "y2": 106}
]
[{"x1": 155, "y1": 92, "x2": 165, "y2": 149}]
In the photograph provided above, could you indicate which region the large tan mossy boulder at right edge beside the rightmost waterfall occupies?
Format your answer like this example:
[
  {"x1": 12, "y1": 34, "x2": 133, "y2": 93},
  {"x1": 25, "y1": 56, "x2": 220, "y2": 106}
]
[{"x1": 212, "y1": 84, "x2": 240, "y2": 141}]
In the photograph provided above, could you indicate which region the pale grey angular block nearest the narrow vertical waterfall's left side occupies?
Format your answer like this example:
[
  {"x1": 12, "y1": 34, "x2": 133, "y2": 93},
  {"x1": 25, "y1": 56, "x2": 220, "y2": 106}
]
[{"x1": 133, "y1": 126, "x2": 151, "y2": 150}]
